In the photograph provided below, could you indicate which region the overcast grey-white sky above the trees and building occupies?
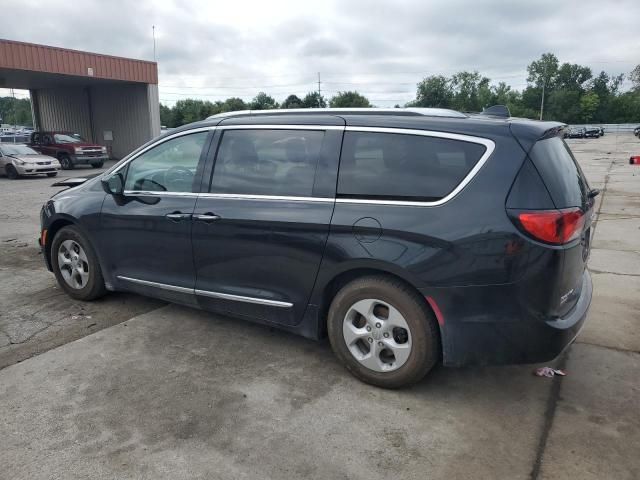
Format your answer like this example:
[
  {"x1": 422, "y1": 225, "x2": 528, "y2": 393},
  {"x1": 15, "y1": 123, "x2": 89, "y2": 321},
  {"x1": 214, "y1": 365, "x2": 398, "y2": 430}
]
[{"x1": 0, "y1": 0, "x2": 640, "y2": 106}]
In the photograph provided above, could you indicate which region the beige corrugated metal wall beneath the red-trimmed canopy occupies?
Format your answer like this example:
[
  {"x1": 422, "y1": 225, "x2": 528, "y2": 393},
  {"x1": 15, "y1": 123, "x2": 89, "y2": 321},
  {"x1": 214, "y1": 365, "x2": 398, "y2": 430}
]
[{"x1": 31, "y1": 83, "x2": 160, "y2": 159}]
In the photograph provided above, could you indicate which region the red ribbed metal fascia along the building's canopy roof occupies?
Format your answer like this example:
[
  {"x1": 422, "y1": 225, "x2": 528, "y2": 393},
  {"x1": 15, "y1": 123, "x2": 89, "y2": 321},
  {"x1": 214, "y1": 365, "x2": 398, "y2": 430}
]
[{"x1": 0, "y1": 39, "x2": 158, "y2": 84}]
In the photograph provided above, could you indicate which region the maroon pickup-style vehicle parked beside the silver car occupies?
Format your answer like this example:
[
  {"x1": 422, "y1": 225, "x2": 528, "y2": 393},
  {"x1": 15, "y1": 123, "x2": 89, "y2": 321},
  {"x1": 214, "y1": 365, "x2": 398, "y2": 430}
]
[{"x1": 29, "y1": 132, "x2": 109, "y2": 170}]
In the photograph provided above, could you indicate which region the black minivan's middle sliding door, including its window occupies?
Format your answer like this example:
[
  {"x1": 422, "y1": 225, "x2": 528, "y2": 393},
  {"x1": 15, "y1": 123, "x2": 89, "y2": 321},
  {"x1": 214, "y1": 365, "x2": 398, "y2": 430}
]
[{"x1": 192, "y1": 126, "x2": 342, "y2": 325}]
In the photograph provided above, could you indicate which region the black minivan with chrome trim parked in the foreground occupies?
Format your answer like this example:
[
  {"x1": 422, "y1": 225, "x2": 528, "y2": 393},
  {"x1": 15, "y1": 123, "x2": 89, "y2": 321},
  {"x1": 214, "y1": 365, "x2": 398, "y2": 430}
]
[{"x1": 40, "y1": 109, "x2": 598, "y2": 387}]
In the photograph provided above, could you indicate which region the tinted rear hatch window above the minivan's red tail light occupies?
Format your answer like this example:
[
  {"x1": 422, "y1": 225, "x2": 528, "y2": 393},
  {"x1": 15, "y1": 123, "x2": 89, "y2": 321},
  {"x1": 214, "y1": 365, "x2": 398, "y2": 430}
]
[{"x1": 529, "y1": 137, "x2": 589, "y2": 208}]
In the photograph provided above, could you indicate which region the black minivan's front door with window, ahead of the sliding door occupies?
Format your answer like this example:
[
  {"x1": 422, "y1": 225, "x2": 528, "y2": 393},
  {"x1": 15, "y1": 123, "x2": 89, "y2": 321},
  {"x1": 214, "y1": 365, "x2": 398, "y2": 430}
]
[{"x1": 99, "y1": 131, "x2": 209, "y2": 304}]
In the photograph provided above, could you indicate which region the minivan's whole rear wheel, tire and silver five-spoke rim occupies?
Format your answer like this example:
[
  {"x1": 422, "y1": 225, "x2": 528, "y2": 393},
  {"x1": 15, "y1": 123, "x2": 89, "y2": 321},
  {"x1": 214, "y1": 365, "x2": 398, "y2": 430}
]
[{"x1": 327, "y1": 276, "x2": 440, "y2": 388}]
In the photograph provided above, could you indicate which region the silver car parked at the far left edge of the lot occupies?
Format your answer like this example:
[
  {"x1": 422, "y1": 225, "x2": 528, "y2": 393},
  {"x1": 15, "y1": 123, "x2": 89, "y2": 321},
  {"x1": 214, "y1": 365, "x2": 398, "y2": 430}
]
[{"x1": 0, "y1": 143, "x2": 61, "y2": 180}]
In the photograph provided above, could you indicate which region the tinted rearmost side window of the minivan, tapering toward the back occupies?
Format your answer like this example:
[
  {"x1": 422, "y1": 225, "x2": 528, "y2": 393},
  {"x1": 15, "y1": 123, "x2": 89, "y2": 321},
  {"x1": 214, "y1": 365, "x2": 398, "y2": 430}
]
[{"x1": 338, "y1": 132, "x2": 486, "y2": 201}]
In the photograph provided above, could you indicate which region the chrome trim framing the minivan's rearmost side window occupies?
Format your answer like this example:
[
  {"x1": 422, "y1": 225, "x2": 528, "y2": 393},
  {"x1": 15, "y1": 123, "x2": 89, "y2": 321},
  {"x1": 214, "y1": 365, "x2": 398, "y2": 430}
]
[{"x1": 336, "y1": 127, "x2": 496, "y2": 207}]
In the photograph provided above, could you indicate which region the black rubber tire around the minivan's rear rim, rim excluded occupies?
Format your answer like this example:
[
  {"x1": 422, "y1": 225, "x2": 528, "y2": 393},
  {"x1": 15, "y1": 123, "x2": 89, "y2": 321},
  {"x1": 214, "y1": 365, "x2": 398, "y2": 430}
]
[{"x1": 327, "y1": 275, "x2": 440, "y2": 388}]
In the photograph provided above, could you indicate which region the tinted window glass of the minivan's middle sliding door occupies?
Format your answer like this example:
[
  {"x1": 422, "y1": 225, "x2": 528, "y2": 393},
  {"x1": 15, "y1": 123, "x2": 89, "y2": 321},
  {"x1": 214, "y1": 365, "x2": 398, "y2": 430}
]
[{"x1": 210, "y1": 130, "x2": 324, "y2": 197}]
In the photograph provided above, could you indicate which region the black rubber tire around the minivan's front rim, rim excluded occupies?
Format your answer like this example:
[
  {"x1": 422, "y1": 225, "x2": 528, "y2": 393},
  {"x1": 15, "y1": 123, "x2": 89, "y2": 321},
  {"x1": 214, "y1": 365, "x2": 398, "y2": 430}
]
[{"x1": 50, "y1": 225, "x2": 107, "y2": 301}]
